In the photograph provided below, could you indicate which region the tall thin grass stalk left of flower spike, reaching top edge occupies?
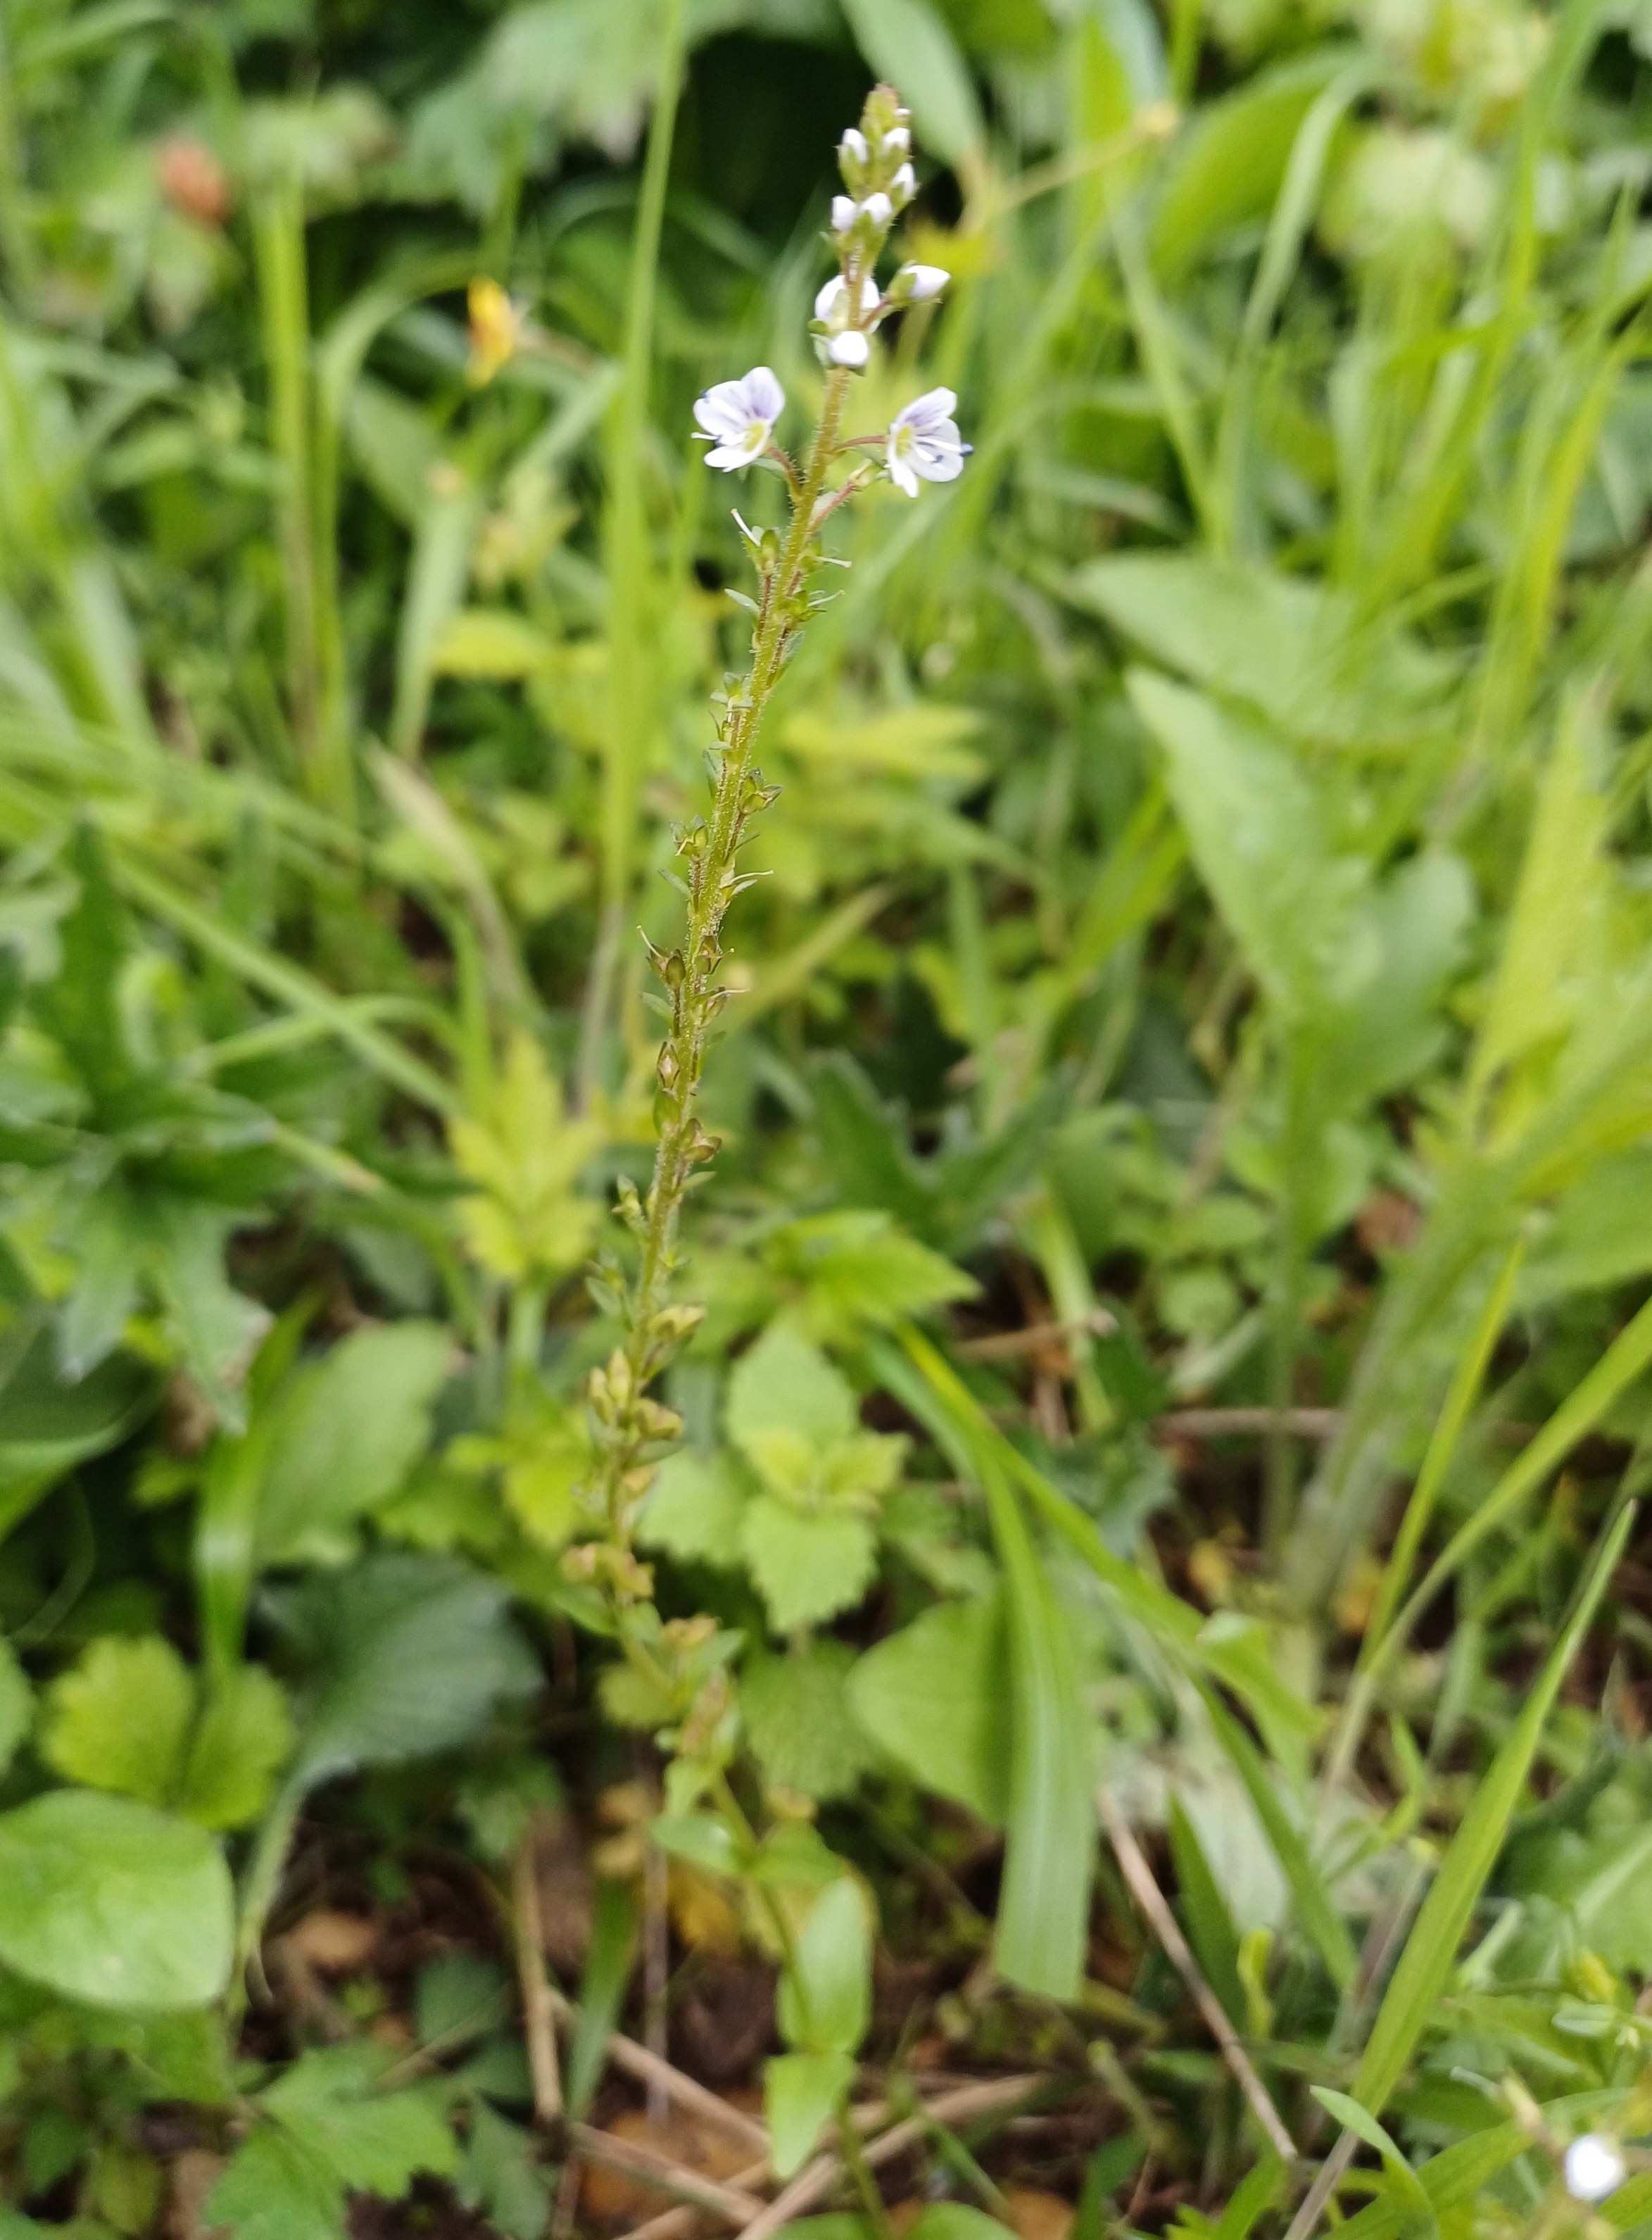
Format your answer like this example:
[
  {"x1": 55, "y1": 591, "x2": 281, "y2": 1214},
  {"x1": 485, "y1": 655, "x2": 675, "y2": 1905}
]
[{"x1": 577, "y1": 0, "x2": 687, "y2": 1105}]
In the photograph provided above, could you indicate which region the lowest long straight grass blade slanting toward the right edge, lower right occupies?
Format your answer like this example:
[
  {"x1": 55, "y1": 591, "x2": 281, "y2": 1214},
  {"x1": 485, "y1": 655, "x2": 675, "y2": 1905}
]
[{"x1": 1352, "y1": 1505, "x2": 1634, "y2": 2115}]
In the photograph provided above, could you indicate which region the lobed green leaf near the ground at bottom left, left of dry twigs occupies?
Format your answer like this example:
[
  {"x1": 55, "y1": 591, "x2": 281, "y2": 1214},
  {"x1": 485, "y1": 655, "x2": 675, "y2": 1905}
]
[{"x1": 264, "y1": 2045, "x2": 459, "y2": 2200}]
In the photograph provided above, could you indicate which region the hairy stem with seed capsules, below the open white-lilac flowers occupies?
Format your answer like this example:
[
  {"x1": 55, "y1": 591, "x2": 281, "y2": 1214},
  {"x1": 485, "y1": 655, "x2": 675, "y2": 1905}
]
[{"x1": 586, "y1": 367, "x2": 848, "y2": 1559}]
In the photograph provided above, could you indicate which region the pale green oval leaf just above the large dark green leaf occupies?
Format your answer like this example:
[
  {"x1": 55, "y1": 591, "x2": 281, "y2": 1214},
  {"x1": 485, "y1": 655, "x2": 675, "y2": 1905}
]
[{"x1": 258, "y1": 1321, "x2": 450, "y2": 1563}]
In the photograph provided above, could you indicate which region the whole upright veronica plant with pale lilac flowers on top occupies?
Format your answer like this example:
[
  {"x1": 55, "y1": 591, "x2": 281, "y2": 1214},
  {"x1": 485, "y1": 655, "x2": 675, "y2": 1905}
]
[{"x1": 564, "y1": 85, "x2": 967, "y2": 2170}]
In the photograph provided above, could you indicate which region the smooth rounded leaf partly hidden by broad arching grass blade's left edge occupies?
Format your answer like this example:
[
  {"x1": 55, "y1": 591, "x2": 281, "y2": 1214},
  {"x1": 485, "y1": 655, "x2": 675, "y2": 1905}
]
[{"x1": 848, "y1": 1595, "x2": 1011, "y2": 1828}]
